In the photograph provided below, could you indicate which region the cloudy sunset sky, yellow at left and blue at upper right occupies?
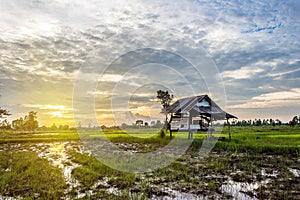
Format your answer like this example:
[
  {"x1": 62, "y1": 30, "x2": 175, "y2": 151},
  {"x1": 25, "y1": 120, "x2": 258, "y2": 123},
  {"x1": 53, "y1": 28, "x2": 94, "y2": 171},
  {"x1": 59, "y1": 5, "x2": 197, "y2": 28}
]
[{"x1": 0, "y1": 0, "x2": 300, "y2": 126}]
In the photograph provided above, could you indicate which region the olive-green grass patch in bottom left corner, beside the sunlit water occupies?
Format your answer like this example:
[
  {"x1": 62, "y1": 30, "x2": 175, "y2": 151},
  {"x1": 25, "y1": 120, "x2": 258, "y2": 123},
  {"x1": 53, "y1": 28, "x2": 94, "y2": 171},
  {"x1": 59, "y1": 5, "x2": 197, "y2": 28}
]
[{"x1": 0, "y1": 151, "x2": 66, "y2": 199}]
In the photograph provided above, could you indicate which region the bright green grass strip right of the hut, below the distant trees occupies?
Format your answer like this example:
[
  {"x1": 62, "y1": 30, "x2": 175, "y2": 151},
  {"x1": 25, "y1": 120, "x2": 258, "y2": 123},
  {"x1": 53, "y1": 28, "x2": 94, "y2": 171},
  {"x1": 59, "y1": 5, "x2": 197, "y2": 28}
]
[{"x1": 215, "y1": 126, "x2": 300, "y2": 155}]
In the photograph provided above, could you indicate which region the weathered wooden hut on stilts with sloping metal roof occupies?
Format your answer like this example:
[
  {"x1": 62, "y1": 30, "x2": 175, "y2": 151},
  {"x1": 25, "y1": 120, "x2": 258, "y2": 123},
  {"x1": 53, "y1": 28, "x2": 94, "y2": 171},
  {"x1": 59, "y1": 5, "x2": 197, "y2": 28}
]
[{"x1": 165, "y1": 95, "x2": 237, "y2": 139}]
